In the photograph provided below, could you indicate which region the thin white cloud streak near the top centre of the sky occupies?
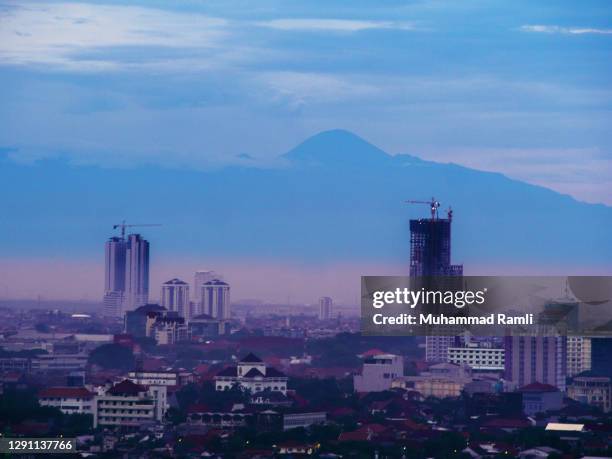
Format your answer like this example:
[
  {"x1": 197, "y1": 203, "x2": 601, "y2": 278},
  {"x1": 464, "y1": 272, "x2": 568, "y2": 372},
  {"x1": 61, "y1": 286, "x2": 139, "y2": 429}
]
[{"x1": 257, "y1": 19, "x2": 415, "y2": 32}]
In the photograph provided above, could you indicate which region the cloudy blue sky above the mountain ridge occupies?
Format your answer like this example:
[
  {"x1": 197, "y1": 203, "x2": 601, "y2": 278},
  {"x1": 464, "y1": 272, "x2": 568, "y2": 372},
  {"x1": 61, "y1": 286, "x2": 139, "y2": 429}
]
[{"x1": 0, "y1": 0, "x2": 612, "y2": 204}]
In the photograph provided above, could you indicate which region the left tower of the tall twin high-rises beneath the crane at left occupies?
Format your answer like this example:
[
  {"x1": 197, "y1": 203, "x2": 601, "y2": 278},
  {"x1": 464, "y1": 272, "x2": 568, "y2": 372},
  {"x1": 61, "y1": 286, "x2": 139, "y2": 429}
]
[{"x1": 103, "y1": 237, "x2": 126, "y2": 317}]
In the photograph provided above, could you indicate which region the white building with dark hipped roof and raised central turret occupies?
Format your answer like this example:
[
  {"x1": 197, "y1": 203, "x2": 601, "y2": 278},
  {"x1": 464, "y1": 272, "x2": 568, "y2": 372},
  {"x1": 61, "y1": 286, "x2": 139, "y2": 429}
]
[{"x1": 215, "y1": 354, "x2": 288, "y2": 395}]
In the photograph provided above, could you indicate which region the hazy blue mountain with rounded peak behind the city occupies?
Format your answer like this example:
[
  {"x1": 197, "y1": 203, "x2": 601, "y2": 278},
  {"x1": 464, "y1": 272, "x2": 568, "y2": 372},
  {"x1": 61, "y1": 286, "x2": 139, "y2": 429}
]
[{"x1": 0, "y1": 130, "x2": 612, "y2": 274}]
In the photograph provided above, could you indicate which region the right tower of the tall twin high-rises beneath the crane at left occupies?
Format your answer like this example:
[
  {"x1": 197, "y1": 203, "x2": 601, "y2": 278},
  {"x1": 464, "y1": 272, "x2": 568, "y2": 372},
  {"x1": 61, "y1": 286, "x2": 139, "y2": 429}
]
[{"x1": 125, "y1": 234, "x2": 149, "y2": 310}]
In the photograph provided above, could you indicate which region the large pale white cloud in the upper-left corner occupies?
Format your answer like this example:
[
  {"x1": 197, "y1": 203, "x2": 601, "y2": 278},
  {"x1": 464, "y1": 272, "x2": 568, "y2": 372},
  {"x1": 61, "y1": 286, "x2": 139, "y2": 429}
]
[{"x1": 0, "y1": 3, "x2": 227, "y2": 70}]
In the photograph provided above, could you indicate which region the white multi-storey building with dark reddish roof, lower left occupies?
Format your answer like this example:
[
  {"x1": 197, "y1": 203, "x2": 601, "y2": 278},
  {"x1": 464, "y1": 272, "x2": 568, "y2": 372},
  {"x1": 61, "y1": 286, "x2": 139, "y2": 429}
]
[{"x1": 93, "y1": 379, "x2": 168, "y2": 429}]
